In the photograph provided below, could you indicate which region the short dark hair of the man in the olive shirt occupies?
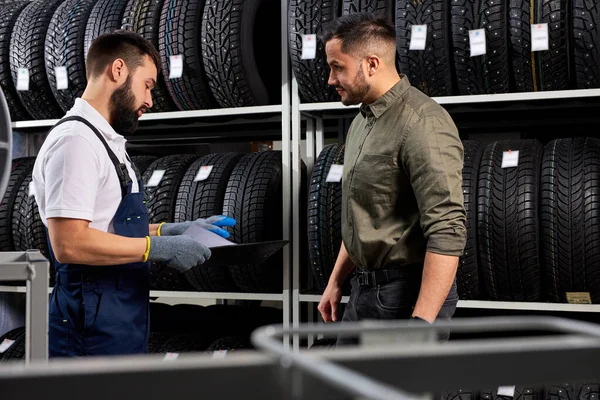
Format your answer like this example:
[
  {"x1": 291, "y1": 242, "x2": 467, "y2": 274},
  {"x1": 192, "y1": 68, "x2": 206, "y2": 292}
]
[{"x1": 320, "y1": 13, "x2": 396, "y2": 54}]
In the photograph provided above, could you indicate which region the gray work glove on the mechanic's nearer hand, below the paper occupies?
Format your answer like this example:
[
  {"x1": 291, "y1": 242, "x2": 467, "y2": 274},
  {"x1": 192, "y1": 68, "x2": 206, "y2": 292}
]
[{"x1": 148, "y1": 236, "x2": 211, "y2": 272}]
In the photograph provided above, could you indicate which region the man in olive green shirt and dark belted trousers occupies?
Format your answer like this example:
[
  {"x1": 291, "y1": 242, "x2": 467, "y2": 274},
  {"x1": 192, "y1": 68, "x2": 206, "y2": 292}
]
[{"x1": 319, "y1": 14, "x2": 466, "y2": 330}]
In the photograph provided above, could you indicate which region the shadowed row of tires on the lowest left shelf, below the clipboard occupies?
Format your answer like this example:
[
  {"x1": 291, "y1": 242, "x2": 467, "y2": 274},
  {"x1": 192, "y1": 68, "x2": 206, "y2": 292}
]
[{"x1": 0, "y1": 303, "x2": 282, "y2": 362}]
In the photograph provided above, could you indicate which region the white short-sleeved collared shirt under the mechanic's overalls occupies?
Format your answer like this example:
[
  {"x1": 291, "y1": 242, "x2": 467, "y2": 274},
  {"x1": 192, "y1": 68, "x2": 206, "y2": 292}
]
[{"x1": 32, "y1": 99, "x2": 139, "y2": 233}]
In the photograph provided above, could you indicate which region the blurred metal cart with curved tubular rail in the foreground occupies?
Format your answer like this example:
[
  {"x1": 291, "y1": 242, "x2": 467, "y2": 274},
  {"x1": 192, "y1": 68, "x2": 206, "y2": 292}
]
[{"x1": 0, "y1": 317, "x2": 600, "y2": 400}]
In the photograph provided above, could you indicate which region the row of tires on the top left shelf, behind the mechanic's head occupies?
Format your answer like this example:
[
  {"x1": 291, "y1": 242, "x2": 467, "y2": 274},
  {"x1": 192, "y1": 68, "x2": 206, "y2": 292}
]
[{"x1": 0, "y1": 0, "x2": 281, "y2": 121}]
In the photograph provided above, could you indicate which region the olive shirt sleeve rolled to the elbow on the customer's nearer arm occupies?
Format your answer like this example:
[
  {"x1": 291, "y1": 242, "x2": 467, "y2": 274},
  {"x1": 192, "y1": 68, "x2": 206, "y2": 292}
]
[{"x1": 399, "y1": 115, "x2": 466, "y2": 256}]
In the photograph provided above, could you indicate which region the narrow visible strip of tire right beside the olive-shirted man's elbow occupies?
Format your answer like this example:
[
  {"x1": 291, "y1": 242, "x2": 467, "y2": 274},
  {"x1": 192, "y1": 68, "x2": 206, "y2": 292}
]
[{"x1": 456, "y1": 140, "x2": 483, "y2": 300}]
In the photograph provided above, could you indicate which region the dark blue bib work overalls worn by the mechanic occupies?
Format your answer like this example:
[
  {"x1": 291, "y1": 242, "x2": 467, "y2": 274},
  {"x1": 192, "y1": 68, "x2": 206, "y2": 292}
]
[{"x1": 48, "y1": 117, "x2": 150, "y2": 357}]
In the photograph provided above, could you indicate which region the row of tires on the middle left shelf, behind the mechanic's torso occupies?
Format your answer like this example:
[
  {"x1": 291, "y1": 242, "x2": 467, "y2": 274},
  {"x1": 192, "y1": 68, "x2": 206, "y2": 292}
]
[{"x1": 0, "y1": 151, "x2": 283, "y2": 293}]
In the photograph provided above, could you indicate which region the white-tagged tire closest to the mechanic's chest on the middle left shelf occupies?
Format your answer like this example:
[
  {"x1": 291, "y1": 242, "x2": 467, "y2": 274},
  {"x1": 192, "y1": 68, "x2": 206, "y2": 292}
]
[{"x1": 143, "y1": 155, "x2": 196, "y2": 291}]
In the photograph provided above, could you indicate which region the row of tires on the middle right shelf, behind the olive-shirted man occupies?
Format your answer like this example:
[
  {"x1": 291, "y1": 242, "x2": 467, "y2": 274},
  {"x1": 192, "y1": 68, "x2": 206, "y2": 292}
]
[{"x1": 308, "y1": 138, "x2": 600, "y2": 303}]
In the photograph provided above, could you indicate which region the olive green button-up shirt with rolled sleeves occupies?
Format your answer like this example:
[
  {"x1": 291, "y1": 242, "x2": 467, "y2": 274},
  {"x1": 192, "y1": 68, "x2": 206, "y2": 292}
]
[{"x1": 342, "y1": 75, "x2": 466, "y2": 269}]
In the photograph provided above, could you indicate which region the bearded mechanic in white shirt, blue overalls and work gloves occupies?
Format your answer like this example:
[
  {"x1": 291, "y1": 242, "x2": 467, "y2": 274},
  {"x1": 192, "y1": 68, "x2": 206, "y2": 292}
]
[{"x1": 33, "y1": 31, "x2": 235, "y2": 357}]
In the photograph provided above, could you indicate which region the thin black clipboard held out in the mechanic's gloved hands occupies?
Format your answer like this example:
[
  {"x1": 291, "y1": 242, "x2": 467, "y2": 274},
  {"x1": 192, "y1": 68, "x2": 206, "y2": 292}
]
[{"x1": 199, "y1": 240, "x2": 289, "y2": 268}]
